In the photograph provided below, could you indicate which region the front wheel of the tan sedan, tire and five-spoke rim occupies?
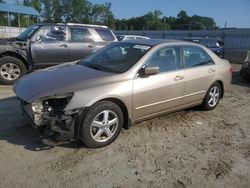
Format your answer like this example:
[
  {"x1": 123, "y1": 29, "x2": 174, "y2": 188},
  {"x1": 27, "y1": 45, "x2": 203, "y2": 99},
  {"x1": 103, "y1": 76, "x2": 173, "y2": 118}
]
[{"x1": 80, "y1": 101, "x2": 124, "y2": 148}]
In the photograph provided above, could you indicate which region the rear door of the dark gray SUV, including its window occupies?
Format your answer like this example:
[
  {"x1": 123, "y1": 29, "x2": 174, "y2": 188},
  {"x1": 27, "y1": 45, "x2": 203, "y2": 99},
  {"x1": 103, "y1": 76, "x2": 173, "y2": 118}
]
[{"x1": 69, "y1": 26, "x2": 96, "y2": 61}]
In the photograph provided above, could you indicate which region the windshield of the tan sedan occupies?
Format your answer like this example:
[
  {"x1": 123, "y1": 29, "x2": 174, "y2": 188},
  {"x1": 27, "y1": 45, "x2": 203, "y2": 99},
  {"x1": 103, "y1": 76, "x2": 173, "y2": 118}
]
[{"x1": 79, "y1": 42, "x2": 151, "y2": 73}]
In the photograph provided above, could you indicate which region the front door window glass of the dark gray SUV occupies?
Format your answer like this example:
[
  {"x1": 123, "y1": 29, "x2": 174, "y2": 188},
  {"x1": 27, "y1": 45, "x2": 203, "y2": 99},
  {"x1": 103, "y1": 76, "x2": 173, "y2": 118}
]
[{"x1": 34, "y1": 26, "x2": 66, "y2": 41}]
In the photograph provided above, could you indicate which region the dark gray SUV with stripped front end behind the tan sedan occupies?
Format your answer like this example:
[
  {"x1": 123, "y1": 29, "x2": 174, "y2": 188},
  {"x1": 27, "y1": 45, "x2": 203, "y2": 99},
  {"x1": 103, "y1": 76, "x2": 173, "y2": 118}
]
[{"x1": 0, "y1": 24, "x2": 117, "y2": 84}]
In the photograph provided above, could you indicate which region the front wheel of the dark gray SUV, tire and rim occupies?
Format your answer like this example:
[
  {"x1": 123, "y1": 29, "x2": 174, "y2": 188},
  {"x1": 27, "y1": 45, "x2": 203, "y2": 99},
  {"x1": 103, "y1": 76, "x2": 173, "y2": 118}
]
[{"x1": 0, "y1": 56, "x2": 27, "y2": 85}]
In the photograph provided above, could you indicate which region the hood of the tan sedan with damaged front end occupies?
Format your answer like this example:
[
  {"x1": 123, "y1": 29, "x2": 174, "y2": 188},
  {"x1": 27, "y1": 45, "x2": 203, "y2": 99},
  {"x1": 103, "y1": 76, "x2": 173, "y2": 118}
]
[{"x1": 13, "y1": 63, "x2": 116, "y2": 102}]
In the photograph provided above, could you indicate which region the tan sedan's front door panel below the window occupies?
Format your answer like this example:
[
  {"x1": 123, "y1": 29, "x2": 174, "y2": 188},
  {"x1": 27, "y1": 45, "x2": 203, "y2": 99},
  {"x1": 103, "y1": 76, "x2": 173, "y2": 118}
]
[{"x1": 133, "y1": 70, "x2": 185, "y2": 121}]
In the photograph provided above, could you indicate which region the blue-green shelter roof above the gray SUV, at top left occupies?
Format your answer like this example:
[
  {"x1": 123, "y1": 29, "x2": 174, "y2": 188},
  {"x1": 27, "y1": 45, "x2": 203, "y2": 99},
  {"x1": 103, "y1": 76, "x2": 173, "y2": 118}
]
[{"x1": 0, "y1": 3, "x2": 39, "y2": 16}]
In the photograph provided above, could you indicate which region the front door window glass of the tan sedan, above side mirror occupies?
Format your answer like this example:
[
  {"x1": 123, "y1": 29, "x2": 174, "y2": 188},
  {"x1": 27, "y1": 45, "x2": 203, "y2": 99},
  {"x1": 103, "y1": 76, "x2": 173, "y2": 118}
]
[{"x1": 146, "y1": 47, "x2": 180, "y2": 72}]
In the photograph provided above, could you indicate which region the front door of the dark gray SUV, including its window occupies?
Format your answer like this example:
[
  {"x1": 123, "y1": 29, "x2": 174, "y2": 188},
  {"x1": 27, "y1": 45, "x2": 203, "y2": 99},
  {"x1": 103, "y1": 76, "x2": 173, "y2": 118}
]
[{"x1": 30, "y1": 26, "x2": 69, "y2": 66}]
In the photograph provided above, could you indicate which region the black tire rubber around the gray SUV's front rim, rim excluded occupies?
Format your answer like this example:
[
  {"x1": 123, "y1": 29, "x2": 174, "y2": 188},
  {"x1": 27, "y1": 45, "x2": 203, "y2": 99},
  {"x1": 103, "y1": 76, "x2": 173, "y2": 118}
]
[{"x1": 0, "y1": 56, "x2": 27, "y2": 85}]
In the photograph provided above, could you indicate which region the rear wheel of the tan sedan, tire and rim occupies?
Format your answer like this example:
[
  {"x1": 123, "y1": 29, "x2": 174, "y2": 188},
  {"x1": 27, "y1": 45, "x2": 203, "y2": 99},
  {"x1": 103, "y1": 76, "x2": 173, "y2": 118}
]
[{"x1": 201, "y1": 82, "x2": 222, "y2": 110}]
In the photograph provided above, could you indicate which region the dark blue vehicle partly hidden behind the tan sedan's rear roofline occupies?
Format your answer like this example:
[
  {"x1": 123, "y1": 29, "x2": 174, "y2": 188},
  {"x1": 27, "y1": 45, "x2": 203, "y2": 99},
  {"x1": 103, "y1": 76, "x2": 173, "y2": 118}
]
[{"x1": 183, "y1": 37, "x2": 224, "y2": 58}]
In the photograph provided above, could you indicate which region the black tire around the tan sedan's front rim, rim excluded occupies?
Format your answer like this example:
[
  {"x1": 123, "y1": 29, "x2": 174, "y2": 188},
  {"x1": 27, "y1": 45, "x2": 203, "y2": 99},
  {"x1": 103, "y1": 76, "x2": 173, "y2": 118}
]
[{"x1": 80, "y1": 101, "x2": 124, "y2": 148}]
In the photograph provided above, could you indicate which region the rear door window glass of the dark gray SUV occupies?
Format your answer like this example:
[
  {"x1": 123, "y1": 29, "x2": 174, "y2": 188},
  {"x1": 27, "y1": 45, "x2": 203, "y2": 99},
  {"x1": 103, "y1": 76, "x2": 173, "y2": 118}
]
[{"x1": 70, "y1": 27, "x2": 92, "y2": 42}]
